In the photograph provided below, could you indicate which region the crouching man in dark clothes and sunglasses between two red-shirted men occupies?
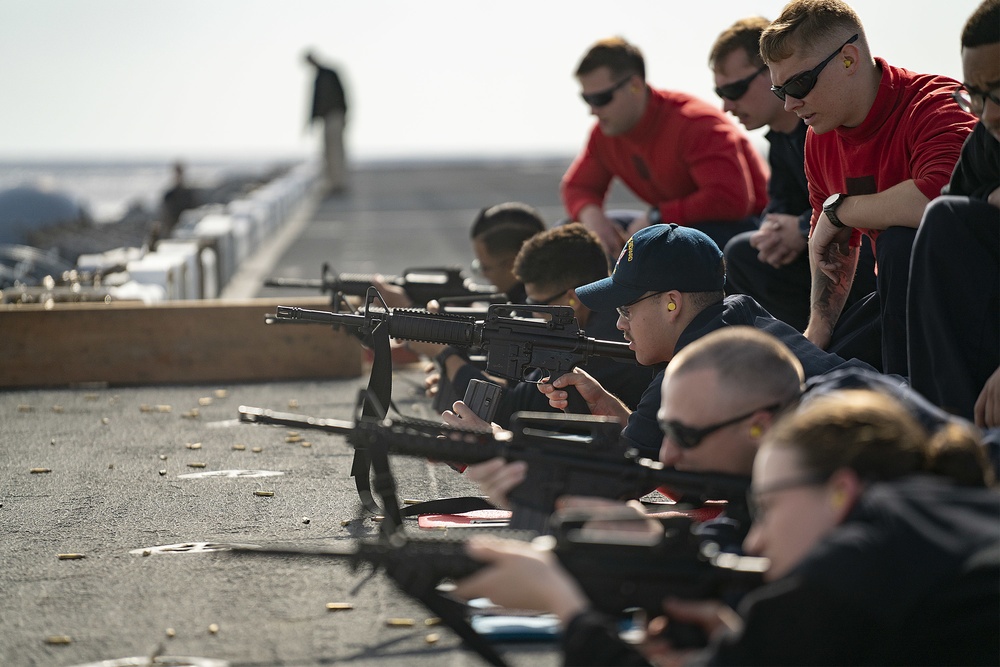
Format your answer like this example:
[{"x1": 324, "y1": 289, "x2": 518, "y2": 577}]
[{"x1": 708, "y1": 16, "x2": 875, "y2": 331}]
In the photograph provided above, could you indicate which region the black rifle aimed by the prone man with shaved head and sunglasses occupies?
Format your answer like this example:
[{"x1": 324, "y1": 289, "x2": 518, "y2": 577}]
[{"x1": 240, "y1": 407, "x2": 750, "y2": 532}]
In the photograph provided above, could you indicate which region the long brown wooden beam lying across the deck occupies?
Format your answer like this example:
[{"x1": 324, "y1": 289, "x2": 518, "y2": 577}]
[{"x1": 0, "y1": 297, "x2": 362, "y2": 388}]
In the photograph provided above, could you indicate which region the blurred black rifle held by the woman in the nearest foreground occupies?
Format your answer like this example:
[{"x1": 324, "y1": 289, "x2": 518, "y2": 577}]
[{"x1": 228, "y1": 513, "x2": 769, "y2": 665}]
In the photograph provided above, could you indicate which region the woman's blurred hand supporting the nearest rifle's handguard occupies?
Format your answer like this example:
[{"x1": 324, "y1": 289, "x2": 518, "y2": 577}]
[{"x1": 453, "y1": 536, "x2": 588, "y2": 625}]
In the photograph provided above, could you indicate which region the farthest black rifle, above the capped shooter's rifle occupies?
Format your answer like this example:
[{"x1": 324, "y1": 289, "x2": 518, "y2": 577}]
[{"x1": 264, "y1": 263, "x2": 507, "y2": 308}]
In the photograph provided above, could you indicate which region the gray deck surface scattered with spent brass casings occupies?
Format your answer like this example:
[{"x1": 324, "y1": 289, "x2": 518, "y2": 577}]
[{"x1": 0, "y1": 161, "x2": 633, "y2": 667}]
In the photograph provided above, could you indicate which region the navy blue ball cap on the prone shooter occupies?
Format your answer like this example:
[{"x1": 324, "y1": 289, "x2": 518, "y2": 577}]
[{"x1": 576, "y1": 223, "x2": 726, "y2": 311}]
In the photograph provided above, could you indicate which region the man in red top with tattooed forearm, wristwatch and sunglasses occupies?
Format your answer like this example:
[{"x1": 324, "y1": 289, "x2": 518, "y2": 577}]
[{"x1": 760, "y1": 0, "x2": 975, "y2": 376}]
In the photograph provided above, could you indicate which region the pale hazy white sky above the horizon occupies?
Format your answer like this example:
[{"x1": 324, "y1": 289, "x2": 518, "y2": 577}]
[{"x1": 0, "y1": 0, "x2": 979, "y2": 160}]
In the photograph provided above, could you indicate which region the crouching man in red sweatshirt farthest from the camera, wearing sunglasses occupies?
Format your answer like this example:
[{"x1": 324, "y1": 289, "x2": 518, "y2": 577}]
[{"x1": 561, "y1": 38, "x2": 767, "y2": 257}]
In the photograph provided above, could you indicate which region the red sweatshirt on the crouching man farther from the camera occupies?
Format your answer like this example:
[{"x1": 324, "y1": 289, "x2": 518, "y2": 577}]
[{"x1": 561, "y1": 88, "x2": 768, "y2": 225}]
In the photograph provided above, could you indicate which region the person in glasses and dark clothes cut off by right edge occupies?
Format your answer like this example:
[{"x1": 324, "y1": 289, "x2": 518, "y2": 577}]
[{"x1": 907, "y1": 0, "x2": 1000, "y2": 433}]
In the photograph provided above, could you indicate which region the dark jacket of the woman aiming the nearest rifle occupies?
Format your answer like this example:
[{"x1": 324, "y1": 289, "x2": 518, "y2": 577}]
[{"x1": 563, "y1": 476, "x2": 1000, "y2": 666}]
